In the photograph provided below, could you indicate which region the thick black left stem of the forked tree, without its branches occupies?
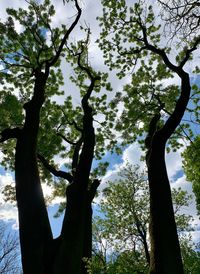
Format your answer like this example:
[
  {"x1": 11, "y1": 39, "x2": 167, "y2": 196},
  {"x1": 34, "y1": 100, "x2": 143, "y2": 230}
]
[{"x1": 15, "y1": 72, "x2": 53, "y2": 274}]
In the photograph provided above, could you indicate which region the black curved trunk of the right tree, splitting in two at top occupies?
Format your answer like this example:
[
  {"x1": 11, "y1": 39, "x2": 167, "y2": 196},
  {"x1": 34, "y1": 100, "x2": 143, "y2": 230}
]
[{"x1": 142, "y1": 47, "x2": 191, "y2": 274}]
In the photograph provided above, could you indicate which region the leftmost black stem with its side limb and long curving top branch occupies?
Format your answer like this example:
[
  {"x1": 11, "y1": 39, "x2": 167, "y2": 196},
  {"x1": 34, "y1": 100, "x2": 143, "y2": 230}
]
[{"x1": 0, "y1": 0, "x2": 82, "y2": 274}]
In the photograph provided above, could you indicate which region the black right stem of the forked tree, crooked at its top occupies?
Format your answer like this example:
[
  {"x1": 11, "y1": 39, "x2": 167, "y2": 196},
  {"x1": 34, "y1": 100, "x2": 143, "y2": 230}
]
[{"x1": 54, "y1": 74, "x2": 96, "y2": 274}]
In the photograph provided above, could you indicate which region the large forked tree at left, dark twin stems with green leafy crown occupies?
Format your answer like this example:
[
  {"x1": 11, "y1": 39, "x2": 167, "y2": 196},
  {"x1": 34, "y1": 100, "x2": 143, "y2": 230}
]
[{"x1": 0, "y1": 0, "x2": 109, "y2": 274}]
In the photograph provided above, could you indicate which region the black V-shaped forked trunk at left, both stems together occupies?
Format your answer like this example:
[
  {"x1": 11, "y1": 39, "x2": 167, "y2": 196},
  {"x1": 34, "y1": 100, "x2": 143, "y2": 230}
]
[{"x1": 9, "y1": 37, "x2": 99, "y2": 274}]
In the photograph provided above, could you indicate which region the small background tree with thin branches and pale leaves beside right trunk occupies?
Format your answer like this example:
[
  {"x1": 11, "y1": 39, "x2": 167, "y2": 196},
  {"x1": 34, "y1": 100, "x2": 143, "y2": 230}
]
[{"x1": 100, "y1": 164, "x2": 150, "y2": 267}]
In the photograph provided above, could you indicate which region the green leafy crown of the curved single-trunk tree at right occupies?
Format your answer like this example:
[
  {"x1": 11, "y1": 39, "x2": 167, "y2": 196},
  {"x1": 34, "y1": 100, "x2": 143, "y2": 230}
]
[{"x1": 98, "y1": 0, "x2": 199, "y2": 150}]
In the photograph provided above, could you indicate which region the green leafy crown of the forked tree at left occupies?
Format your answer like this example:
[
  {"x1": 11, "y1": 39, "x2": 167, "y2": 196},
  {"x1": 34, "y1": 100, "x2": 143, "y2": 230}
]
[{"x1": 0, "y1": 0, "x2": 112, "y2": 192}]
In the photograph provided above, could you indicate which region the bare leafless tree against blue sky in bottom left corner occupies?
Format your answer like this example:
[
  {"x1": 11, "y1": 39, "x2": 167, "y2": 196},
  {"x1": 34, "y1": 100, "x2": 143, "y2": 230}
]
[{"x1": 0, "y1": 222, "x2": 22, "y2": 274}]
